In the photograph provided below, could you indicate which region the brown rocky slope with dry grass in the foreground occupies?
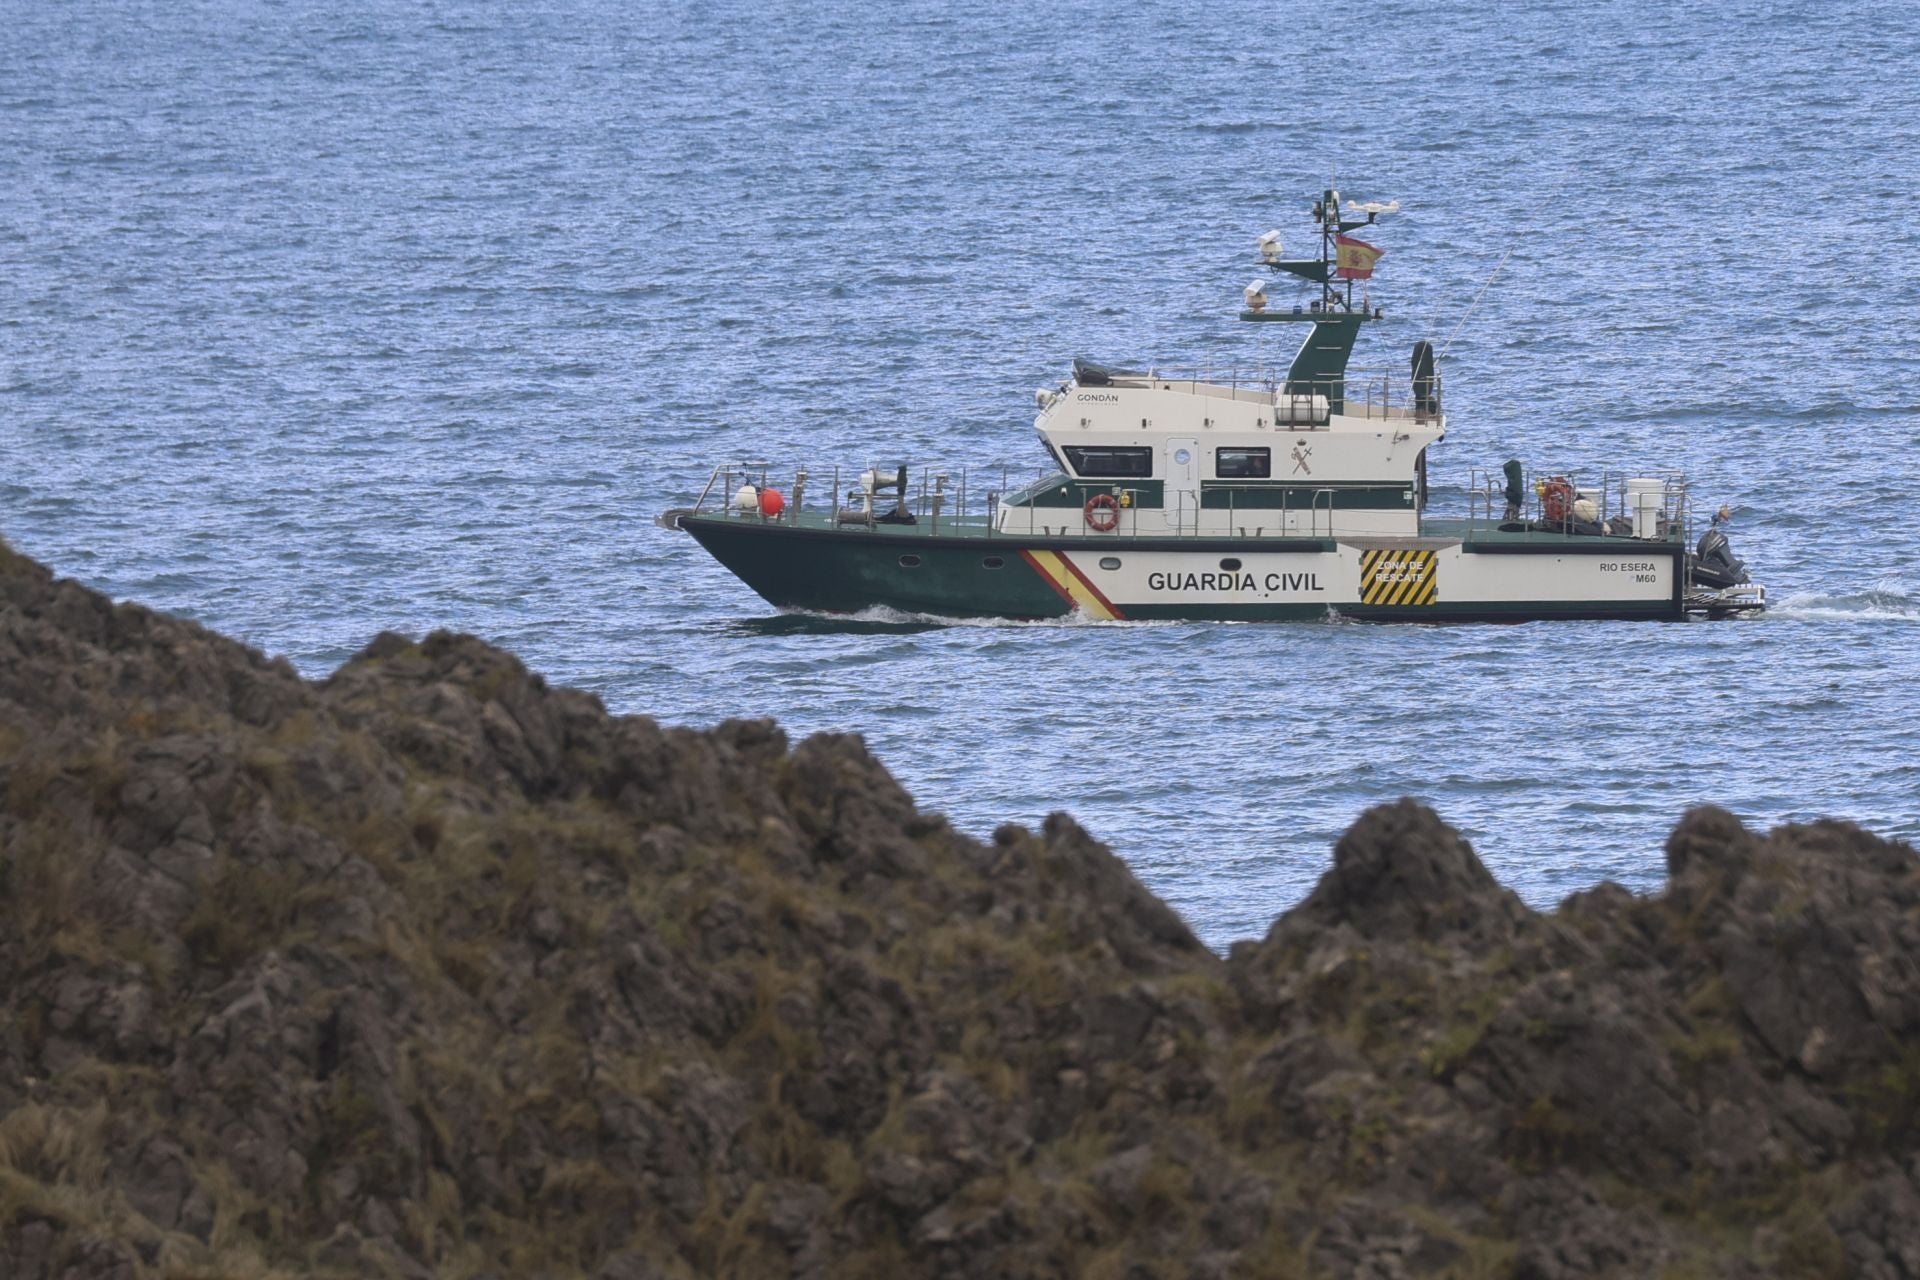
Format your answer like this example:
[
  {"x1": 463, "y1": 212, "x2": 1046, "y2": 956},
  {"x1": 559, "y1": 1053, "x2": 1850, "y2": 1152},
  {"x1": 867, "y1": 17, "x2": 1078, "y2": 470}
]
[{"x1": 0, "y1": 545, "x2": 1920, "y2": 1280}]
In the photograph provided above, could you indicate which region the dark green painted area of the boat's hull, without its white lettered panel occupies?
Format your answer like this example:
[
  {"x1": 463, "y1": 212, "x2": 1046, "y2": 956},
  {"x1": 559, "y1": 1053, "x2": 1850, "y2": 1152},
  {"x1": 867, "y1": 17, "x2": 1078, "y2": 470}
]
[{"x1": 680, "y1": 516, "x2": 1684, "y2": 622}]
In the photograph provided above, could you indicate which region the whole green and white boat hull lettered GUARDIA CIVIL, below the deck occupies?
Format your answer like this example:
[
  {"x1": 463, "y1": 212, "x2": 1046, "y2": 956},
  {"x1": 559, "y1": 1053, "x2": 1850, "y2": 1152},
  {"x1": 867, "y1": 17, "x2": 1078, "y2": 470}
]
[{"x1": 680, "y1": 516, "x2": 1686, "y2": 622}]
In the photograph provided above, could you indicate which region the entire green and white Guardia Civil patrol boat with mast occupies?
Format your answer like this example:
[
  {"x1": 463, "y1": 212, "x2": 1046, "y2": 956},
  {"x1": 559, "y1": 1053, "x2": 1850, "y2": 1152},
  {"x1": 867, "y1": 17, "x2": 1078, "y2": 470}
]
[{"x1": 659, "y1": 190, "x2": 1766, "y2": 622}]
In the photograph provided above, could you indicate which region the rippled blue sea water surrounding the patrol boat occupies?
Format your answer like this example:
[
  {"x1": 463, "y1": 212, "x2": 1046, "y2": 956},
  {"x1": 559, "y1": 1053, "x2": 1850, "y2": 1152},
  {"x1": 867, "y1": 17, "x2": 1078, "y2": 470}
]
[{"x1": 0, "y1": 0, "x2": 1920, "y2": 946}]
